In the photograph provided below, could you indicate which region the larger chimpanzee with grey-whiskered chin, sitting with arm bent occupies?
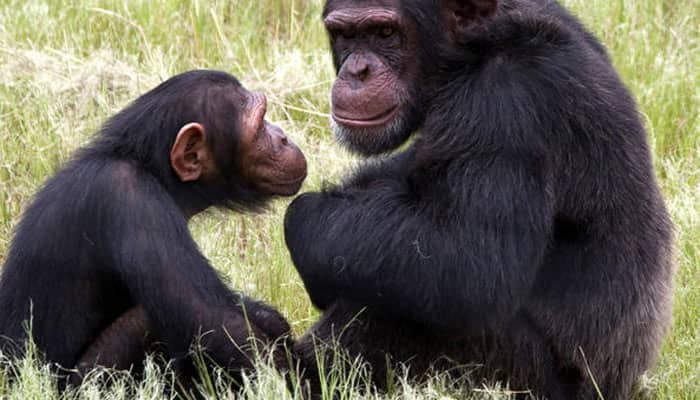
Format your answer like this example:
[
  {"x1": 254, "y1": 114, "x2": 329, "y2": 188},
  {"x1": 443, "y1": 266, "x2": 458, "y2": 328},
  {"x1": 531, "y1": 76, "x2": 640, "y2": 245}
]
[{"x1": 285, "y1": 0, "x2": 673, "y2": 399}]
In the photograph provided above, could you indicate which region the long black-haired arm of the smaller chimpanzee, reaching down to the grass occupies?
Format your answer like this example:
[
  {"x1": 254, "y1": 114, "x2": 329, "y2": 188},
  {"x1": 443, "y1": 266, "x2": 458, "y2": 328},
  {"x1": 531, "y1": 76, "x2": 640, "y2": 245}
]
[{"x1": 104, "y1": 172, "x2": 261, "y2": 366}]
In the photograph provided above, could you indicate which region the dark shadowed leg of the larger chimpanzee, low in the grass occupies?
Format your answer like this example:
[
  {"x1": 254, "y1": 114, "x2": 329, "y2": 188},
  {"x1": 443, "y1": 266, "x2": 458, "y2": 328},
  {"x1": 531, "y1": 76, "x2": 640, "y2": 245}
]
[{"x1": 294, "y1": 299, "x2": 579, "y2": 400}]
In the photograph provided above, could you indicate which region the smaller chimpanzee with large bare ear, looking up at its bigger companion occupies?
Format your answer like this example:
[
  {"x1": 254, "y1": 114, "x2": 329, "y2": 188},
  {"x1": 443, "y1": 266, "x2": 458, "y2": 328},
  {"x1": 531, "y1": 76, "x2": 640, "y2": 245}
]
[{"x1": 0, "y1": 71, "x2": 306, "y2": 388}]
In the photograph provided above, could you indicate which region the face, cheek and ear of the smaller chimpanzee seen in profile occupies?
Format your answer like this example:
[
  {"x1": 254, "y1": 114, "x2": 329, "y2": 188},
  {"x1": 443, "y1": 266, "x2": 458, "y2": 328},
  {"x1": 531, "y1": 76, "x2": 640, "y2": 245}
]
[{"x1": 170, "y1": 85, "x2": 306, "y2": 200}]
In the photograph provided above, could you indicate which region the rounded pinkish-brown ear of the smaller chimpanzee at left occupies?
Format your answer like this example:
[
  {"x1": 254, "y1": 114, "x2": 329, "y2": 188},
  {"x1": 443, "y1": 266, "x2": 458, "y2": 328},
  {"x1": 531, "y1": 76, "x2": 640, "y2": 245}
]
[{"x1": 170, "y1": 122, "x2": 210, "y2": 182}]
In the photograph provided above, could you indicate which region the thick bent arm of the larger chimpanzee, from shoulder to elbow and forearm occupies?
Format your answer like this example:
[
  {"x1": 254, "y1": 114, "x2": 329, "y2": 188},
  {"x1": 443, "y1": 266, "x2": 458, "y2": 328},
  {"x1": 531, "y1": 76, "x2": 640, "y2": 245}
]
[{"x1": 285, "y1": 68, "x2": 554, "y2": 330}]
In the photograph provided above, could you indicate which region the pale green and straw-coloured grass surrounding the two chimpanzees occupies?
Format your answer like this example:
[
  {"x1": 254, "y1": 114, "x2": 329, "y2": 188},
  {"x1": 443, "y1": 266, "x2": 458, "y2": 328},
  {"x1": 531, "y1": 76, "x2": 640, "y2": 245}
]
[{"x1": 0, "y1": 0, "x2": 700, "y2": 399}]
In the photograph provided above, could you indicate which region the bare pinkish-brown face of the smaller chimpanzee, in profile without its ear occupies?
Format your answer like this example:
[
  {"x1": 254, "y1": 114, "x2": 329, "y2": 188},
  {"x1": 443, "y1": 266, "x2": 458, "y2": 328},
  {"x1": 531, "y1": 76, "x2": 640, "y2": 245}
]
[{"x1": 238, "y1": 91, "x2": 306, "y2": 196}]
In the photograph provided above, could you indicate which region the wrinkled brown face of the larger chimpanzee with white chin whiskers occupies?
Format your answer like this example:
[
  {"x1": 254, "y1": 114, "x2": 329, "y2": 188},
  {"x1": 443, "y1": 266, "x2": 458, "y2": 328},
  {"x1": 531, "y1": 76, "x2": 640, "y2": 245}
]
[{"x1": 324, "y1": 1, "x2": 420, "y2": 155}]
